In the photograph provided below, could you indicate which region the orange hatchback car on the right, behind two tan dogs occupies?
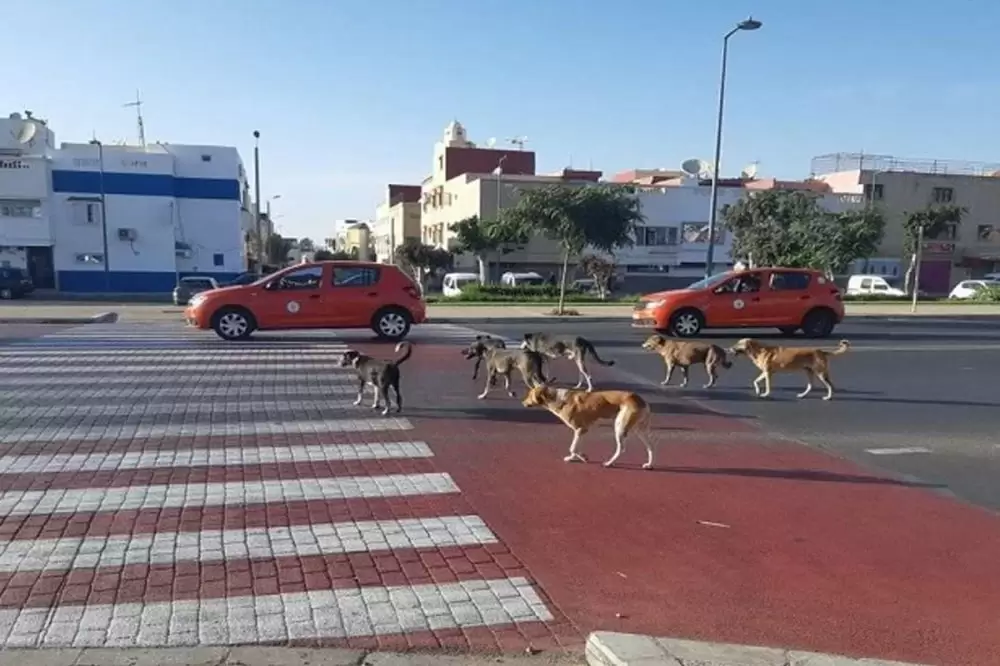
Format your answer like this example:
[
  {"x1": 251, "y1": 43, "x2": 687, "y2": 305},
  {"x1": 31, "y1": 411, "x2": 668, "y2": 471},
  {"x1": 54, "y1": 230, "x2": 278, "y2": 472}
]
[{"x1": 632, "y1": 268, "x2": 844, "y2": 338}]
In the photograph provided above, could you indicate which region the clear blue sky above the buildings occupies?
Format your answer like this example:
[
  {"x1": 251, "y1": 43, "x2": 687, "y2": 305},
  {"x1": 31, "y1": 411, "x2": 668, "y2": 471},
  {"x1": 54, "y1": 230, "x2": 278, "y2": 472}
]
[{"x1": 11, "y1": 0, "x2": 1000, "y2": 240}]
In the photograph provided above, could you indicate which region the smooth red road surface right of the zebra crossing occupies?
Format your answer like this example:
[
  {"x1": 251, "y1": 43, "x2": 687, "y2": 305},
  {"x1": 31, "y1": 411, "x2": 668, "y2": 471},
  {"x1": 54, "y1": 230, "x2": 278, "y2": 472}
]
[{"x1": 390, "y1": 345, "x2": 1000, "y2": 665}]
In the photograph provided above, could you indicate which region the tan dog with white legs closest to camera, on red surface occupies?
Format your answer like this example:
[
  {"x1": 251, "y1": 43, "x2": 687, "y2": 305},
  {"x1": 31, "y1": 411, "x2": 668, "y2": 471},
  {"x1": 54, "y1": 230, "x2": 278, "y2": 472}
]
[{"x1": 521, "y1": 386, "x2": 653, "y2": 469}]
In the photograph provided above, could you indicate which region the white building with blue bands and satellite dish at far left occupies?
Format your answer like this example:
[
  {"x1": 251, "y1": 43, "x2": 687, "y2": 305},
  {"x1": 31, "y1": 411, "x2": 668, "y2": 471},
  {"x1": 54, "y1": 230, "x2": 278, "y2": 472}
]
[{"x1": 0, "y1": 114, "x2": 253, "y2": 293}]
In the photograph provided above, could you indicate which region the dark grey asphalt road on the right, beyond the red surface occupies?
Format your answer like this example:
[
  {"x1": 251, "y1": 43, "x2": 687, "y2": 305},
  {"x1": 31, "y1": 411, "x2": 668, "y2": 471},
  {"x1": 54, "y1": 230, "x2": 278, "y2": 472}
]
[{"x1": 472, "y1": 317, "x2": 1000, "y2": 510}]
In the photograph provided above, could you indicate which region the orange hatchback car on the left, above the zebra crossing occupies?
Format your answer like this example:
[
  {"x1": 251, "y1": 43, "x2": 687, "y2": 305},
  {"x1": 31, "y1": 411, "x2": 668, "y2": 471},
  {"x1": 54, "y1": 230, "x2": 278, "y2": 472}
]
[{"x1": 184, "y1": 261, "x2": 427, "y2": 340}]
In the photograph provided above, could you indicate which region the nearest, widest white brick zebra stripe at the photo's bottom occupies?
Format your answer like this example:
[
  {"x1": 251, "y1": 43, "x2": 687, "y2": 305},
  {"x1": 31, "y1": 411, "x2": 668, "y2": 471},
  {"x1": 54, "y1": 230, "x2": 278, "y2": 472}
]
[{"x1": 0, "y1": 578, "x2": 553, "y2": 648}]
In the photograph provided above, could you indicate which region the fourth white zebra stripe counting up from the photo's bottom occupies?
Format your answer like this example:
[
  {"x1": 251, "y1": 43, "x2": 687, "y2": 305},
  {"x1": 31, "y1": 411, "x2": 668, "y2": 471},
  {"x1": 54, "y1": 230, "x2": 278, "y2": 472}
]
[{"x1": 0, "y1": 442, "x2": 434, "y2": 474}]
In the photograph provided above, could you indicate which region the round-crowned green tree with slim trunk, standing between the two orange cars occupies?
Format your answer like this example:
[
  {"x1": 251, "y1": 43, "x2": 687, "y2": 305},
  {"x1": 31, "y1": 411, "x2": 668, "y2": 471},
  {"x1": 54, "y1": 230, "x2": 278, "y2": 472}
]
[{"x1": 500, "y1": 184, "x2": 644, "y2": 314}]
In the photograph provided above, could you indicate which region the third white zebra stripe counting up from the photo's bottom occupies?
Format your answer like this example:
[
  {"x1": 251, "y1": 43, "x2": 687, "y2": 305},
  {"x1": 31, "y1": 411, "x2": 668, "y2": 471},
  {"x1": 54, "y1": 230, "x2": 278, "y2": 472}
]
[{"x1": 0, "y1": 473, "x2": 459, "y2": 516}]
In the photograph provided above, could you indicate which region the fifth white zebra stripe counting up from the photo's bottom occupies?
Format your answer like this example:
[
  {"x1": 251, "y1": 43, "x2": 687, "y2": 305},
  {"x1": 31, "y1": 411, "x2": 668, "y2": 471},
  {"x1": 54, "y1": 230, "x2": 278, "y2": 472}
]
[{"x1": 0, "y1": 417, "x2": 413, "y2": 444}]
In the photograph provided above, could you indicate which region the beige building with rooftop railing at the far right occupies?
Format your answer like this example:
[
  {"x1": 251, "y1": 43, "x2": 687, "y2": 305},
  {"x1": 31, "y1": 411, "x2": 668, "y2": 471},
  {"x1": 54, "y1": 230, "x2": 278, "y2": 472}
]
[{"x1": 812, "y1": 153, "x2": 1000, "y2": 293}]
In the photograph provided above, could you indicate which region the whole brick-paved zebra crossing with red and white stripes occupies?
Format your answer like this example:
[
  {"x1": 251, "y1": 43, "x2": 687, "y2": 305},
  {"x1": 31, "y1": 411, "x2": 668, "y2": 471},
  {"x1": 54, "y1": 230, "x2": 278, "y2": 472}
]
[{"x1": 0, "y1": 324, "x2": 554, "y2": 649}]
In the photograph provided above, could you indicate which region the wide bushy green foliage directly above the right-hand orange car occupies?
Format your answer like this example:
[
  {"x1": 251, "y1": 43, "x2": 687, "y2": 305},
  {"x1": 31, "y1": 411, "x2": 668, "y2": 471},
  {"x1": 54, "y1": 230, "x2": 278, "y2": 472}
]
[{"x1": 723, "y1": 190, "x2": 885, "y2": 273}]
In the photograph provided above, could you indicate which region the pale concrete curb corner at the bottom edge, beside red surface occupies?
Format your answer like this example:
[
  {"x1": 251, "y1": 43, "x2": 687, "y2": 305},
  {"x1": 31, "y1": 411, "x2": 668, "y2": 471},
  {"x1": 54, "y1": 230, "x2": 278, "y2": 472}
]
[{"x1": 586, "y1": 631, "x2": 925, "y2": 666}]
